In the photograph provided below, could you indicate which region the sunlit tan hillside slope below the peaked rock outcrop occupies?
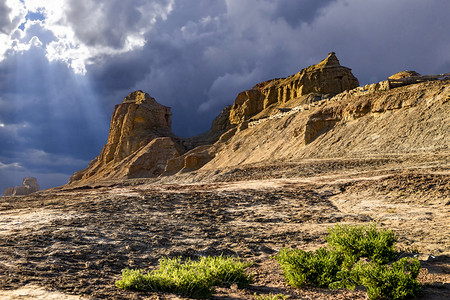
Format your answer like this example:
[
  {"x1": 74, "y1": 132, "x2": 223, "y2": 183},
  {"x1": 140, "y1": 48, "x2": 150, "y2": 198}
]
[{"x1": 204, "y1": 79, "x2": 450, "y2": 169}]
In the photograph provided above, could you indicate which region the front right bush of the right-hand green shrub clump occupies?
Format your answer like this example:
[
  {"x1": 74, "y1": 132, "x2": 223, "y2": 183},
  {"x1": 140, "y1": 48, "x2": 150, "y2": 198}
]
[{"x1": 330, "y1": 257, "x2": 421, "y2": 300}]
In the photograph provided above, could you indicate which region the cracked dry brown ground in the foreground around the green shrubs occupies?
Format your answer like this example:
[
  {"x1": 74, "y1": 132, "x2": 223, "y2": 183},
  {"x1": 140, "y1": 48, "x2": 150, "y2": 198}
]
[{"x1": 0, "y1": 165, "x2": 450, "y2": 299}]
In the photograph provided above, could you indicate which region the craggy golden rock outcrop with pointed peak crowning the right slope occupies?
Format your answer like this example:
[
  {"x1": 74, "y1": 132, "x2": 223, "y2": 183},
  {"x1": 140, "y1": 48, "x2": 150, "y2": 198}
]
[{"x1": 230, "y1": 52, "x2": 359, "y2": 124}]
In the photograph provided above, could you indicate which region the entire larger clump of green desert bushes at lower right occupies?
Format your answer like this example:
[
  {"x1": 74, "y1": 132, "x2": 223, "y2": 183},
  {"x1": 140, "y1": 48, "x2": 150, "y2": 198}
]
[{"x1": 276, "y1": 224, "x2": 421, "y2": 299}]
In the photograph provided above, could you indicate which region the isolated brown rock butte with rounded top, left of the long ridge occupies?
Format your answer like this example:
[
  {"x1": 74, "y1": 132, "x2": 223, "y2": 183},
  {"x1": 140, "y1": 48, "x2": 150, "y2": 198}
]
[{"x1": 69, "y1": 90, "x2": 181, "y2": 183}]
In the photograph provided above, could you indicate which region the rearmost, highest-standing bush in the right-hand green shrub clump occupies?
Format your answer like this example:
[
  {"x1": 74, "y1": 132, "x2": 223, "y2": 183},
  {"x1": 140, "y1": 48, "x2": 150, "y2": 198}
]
[{"x1": 325, "y1": 224, "x2": 397, "y2": 264}]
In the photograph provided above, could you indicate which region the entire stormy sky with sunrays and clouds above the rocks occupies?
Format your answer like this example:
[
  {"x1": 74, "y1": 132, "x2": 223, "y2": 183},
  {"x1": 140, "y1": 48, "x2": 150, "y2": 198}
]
[{"x1": 0, "y1": 0, "x2": 450, "y2": 191}]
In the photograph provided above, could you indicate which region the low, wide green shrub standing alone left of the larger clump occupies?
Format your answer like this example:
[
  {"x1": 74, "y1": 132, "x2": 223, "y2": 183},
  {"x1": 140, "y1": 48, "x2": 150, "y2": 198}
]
[{"x1": 116, "y1": 256, "x2": 252, "y2": 298}]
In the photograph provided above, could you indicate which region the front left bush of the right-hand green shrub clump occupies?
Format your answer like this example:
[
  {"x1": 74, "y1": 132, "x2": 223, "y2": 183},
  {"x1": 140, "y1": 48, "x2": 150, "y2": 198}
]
[{"x1": 276, "y1": 248, "x2": 343, "y2": 287}]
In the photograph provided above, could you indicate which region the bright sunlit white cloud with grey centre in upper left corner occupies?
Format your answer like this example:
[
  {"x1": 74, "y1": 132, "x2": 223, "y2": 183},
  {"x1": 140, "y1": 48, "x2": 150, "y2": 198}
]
[{"x1": 0, "y1": 0, "x2": 174, "y2": 74}]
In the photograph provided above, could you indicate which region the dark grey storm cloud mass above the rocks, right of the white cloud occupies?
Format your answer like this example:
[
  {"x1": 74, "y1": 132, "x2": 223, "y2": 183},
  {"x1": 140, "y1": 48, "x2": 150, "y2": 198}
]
[{"x1": 54, "y1": 0, "x2": 448, "y2": 136}]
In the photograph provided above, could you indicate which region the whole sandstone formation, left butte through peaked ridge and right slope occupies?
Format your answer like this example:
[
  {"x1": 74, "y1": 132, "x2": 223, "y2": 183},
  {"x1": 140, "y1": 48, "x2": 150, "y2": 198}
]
[{"x1": 69, "y1": 52, "x2": 450, "y2": 185}]
